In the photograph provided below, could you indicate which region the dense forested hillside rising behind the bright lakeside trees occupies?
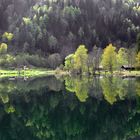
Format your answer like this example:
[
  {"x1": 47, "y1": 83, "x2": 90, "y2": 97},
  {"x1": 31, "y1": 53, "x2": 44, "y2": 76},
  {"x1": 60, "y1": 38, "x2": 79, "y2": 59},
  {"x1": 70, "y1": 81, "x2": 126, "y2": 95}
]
[{"x1": 0, "y1": 0, "x2": 140, "y2": 68}]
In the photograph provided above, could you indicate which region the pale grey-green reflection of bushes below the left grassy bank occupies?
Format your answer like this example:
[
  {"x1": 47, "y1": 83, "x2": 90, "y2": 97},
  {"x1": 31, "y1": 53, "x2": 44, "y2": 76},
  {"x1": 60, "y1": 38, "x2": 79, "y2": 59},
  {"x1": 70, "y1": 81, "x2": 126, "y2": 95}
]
[{"x1": 0, "y1": 77, "x2": 63, "y2": 103}]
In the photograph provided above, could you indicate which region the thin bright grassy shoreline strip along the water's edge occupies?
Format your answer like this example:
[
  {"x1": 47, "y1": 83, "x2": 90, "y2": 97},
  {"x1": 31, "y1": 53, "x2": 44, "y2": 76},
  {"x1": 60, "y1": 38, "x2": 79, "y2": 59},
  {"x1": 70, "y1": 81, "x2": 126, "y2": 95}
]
[{"x1": 0, "y1": 69, "x2": 140, "y2": 78}]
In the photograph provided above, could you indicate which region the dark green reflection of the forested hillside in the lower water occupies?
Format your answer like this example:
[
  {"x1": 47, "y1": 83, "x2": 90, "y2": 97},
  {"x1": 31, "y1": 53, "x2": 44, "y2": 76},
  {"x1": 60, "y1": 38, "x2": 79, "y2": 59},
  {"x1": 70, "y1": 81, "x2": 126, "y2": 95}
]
[{"x1": 0, "y1": 91, "x2": 140, "y2": 140}]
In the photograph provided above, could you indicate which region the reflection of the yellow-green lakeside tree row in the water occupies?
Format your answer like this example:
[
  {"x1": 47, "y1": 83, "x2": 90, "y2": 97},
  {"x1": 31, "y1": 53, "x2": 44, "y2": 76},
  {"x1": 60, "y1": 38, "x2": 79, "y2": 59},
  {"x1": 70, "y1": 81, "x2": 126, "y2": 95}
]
[{"x1": 65, "y1": 77, "x2": 140, "y2": 105}]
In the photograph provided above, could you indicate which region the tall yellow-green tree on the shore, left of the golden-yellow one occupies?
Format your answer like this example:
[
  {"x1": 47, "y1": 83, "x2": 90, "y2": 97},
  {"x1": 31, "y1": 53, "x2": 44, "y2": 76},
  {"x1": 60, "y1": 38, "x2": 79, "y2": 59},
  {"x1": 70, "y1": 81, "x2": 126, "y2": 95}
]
[{"x1": 74, "y1": 45, "x2": 88, "y2": 73}]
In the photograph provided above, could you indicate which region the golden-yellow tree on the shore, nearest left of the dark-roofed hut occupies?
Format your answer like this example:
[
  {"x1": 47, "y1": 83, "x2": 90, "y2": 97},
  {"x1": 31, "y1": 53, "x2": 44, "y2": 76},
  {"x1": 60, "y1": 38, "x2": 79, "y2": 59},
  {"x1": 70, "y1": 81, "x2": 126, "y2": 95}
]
[{"x1": 101, "y1": 44, "x2": 117, "y2": 73}]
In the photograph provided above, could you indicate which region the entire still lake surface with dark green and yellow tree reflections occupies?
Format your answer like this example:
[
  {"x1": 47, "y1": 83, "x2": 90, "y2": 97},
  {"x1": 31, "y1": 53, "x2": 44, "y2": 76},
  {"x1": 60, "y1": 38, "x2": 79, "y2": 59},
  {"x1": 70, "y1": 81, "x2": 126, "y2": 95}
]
[{"x1": 0, "y1": 77, "x2": 140, "y2": 140}]
